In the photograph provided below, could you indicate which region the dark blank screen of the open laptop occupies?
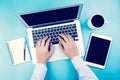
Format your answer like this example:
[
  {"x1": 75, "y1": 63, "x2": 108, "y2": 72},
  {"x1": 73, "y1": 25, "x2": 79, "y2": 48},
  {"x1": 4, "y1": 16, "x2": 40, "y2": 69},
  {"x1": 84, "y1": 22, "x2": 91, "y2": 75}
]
[{"x1": 20, "y1": 5, "x2": 82, "y2": 26}]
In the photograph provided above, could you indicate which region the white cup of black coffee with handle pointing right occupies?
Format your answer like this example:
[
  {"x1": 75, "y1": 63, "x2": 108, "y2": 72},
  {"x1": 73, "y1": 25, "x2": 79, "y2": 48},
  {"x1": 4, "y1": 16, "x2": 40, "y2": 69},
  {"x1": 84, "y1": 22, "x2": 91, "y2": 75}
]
[{"x1": 88, "y1": 14, "x2": 109, "y2": 29}]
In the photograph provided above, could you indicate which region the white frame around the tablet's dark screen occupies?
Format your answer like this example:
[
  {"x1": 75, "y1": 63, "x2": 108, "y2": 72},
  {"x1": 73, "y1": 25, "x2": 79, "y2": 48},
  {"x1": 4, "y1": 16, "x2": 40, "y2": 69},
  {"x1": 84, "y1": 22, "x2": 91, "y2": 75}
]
[{"x1": 84, "y1": 33, "x2": 112, "y2": 69}]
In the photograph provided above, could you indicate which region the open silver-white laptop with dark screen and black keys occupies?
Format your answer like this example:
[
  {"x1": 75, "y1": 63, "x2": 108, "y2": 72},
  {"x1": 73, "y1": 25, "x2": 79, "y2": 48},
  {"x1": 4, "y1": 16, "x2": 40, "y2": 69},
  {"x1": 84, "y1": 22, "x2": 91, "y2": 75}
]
[{"x1": 18, "y1": 4, "x2": 84, "y2": 64}]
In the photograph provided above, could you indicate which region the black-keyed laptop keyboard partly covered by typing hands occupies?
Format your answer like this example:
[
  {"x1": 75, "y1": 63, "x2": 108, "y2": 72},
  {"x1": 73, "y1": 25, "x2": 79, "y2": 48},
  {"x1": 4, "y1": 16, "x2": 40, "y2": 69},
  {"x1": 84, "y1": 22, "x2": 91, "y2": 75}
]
[{"x1": 32, "y1": 24, "x2": 78, "y2": 47}]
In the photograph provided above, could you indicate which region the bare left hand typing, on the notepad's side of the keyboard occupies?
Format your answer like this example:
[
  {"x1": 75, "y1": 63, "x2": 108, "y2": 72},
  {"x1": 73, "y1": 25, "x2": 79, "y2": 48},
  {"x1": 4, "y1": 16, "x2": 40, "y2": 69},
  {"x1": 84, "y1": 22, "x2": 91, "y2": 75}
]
[{"x1": 36, "y1": 37, "x2": 53, "y2": 64}]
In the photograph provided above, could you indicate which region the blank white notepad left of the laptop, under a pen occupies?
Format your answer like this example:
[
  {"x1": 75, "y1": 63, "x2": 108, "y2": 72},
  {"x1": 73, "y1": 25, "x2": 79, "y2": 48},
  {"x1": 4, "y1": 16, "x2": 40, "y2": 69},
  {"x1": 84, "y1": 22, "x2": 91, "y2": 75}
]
[{"x1": 8, "y1": 38, "x2": 30, "y2": 64}]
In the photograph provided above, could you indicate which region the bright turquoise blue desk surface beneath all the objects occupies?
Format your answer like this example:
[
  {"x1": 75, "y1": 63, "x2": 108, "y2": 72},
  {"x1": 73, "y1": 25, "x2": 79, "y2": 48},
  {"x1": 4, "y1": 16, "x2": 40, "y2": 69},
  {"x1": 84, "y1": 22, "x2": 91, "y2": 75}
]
[{"x1": 0, "y1": 0, "x2": 120, "y2": 80}]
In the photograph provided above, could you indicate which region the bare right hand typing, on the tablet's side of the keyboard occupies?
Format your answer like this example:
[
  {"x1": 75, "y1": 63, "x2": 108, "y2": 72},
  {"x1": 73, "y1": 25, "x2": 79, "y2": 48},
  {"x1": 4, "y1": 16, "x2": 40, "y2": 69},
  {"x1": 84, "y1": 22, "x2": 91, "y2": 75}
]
[{"x1": 58, "y1": 34, "x2": 79, "y2": 59}]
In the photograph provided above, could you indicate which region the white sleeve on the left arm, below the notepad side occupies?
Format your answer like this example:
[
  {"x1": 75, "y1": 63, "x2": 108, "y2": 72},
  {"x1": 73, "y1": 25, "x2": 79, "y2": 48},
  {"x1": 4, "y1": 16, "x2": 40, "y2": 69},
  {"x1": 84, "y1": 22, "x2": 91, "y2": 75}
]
[{"x1": 31, "y1": 64, "x2": 47, "y2": 80}]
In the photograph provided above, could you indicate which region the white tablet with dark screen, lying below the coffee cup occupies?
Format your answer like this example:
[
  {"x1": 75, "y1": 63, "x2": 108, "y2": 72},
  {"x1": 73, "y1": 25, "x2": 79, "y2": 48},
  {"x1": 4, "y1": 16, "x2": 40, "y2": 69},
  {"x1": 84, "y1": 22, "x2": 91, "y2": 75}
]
[{"x1": 85, "y1": 33, "x2": 112, "y2": 69}]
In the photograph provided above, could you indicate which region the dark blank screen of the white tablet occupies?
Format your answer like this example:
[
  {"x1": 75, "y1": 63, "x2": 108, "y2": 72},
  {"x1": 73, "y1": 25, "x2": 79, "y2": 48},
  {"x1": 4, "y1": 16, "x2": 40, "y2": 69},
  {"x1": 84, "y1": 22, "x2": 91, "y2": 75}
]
[{"x1": 86, "y1": 36, "x2": 111, "y2": 66}]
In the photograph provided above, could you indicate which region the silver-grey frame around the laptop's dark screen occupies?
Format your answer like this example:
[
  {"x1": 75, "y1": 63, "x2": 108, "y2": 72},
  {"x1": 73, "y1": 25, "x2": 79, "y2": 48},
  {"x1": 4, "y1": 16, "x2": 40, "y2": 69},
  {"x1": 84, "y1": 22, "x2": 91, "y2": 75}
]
[{"x1": 17, "y1": 4, "x2": 83, "y2": 27}]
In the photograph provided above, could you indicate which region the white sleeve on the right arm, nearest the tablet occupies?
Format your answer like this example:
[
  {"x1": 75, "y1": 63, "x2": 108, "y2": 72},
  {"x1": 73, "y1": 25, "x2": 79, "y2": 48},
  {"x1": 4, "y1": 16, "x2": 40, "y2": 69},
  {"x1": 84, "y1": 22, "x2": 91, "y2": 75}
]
[{"x1": 72, "y1": 56, "x2": 98, "y2": 80}]
